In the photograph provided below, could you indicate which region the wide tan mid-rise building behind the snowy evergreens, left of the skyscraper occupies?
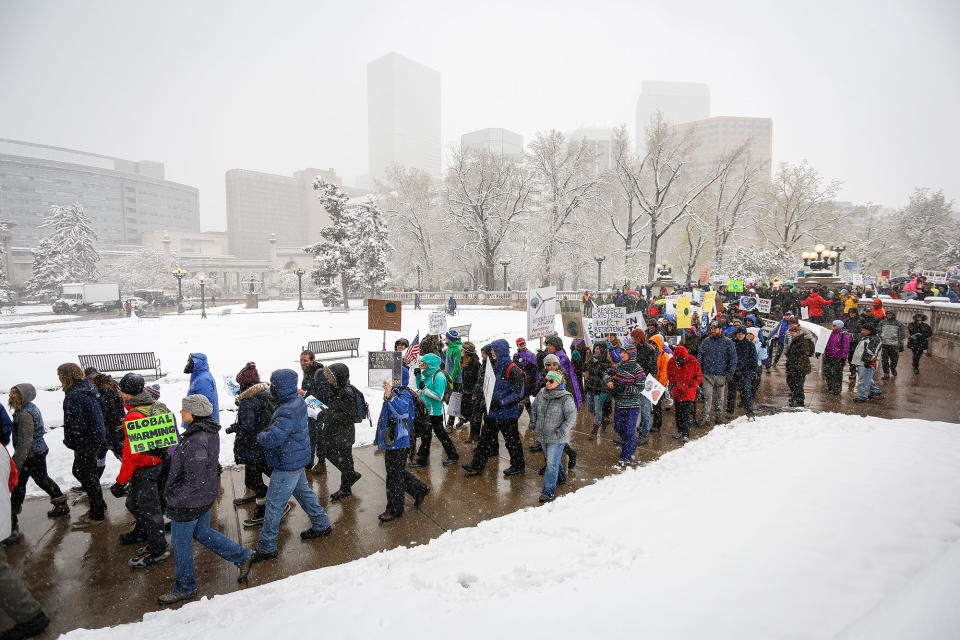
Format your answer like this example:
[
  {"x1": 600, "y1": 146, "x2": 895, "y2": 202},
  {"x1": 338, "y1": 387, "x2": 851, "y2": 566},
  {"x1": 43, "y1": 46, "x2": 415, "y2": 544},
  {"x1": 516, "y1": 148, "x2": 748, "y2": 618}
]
[{"x1": 226, "y1": 169, "x2": 366, "y2": 259}]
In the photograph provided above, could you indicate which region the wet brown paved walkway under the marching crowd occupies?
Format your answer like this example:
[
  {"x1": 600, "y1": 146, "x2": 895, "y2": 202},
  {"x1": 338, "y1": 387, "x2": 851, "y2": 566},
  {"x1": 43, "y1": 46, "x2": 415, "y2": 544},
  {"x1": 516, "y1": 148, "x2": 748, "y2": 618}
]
[{"x1": 7, "y1": 358, "x2": 960, "y2": 638}]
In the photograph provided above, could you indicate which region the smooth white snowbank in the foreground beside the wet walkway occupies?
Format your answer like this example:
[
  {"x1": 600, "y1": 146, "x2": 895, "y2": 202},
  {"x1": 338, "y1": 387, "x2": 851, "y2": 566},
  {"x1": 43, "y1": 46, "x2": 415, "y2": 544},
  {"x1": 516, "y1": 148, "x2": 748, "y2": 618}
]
[{"x1": 58, "y1": 413, "x2": 960, "y2": 640}]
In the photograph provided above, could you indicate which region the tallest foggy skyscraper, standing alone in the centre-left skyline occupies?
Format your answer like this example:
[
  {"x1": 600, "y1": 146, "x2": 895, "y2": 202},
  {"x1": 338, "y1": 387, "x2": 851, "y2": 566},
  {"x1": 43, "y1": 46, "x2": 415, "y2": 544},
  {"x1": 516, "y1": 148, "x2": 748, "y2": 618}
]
[{"x1": 367, "y1": 53, "x2": 440, "y2": 178}]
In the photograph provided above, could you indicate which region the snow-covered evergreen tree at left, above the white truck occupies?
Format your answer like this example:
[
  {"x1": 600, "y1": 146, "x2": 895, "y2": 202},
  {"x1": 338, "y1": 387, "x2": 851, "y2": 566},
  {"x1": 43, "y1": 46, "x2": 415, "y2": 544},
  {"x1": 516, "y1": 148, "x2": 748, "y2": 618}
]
[{"x1": 27, "y1": 203, "x2": 100, "y2": 297}]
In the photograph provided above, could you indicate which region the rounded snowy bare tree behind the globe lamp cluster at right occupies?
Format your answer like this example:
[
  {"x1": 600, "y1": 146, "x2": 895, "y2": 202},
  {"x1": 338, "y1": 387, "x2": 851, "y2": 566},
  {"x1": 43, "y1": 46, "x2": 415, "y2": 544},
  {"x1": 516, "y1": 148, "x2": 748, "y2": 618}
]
[{"x1": 758, "y1": 160, "x2": 840, "y2": 249}]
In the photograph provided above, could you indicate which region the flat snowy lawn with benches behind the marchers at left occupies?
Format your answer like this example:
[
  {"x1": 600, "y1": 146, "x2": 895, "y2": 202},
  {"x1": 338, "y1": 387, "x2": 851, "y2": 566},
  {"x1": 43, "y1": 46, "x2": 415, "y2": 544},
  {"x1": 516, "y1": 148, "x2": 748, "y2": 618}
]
[{"x1": 0, "y1": 300, "x2": 526, "y2": 495}]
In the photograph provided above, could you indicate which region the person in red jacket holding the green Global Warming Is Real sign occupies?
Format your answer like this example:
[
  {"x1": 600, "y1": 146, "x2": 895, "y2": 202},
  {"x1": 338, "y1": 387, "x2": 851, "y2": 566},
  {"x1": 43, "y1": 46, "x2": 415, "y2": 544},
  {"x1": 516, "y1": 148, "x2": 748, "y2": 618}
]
[{"x1": 110, "y1": 373, "x2": 170, "y2": 567}]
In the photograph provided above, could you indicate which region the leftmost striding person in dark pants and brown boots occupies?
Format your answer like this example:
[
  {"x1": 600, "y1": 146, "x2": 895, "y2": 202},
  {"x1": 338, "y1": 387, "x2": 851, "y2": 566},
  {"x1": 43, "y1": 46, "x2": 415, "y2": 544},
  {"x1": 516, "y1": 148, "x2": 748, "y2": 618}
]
[{"x1": 4, "y1": 382, "x2": 70, "y2": 544}]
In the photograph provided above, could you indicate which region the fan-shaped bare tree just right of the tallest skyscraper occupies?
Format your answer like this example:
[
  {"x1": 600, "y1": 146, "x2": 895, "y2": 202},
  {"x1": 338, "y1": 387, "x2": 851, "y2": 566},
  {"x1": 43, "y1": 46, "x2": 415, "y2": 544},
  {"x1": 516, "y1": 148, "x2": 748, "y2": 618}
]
[{"x1": 445, "y1": 148, "x2": 531, "y2": 284}]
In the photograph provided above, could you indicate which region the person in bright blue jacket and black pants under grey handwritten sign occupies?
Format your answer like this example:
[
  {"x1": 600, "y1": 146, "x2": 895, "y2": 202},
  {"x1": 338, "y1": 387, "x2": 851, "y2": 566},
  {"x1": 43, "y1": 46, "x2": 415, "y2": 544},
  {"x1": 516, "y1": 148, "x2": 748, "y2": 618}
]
[{"x1": 376, "y1": 381, "x2": 430, "y2": 522}]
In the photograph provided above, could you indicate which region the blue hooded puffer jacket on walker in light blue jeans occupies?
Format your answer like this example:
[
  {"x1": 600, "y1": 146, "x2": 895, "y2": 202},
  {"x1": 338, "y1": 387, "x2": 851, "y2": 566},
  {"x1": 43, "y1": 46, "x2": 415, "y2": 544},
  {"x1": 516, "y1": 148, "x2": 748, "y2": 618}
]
[{"x1": 257, "y1": 369, "x2": 313, "y2": 471}]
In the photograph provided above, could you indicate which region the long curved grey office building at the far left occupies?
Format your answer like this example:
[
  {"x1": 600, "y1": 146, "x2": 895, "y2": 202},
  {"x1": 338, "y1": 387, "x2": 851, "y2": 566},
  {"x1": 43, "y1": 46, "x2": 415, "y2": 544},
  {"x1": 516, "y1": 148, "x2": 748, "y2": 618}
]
[{"x1": 0, "y1": 139, "x2": 200, "y2": 248}]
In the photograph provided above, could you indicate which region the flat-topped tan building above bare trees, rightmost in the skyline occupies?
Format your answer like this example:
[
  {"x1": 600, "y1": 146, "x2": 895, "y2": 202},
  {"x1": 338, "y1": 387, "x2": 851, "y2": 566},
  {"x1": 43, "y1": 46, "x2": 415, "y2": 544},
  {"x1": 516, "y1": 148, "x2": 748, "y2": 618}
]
[{"x1": 676, "y1": 116, "x2": 773, "y2": 181}]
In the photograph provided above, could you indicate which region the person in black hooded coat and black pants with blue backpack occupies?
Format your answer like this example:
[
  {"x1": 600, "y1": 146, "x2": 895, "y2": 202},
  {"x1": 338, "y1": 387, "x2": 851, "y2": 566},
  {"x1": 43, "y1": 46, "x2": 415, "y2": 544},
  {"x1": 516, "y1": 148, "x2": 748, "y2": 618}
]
[{"x1": 323, "y1": 362, "x2": 362, "y2": 501}]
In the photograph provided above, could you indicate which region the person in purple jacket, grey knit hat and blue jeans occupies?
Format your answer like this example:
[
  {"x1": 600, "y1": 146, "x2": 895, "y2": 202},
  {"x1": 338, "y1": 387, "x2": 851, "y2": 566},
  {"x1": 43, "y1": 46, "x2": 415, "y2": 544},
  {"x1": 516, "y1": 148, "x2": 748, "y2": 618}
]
[{"x1": 157, "y1": 394, "x2": 253, "y2": 605}]
